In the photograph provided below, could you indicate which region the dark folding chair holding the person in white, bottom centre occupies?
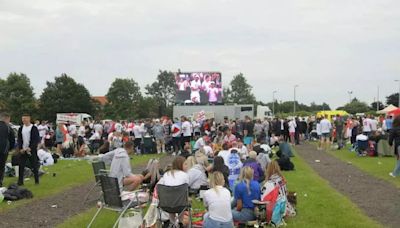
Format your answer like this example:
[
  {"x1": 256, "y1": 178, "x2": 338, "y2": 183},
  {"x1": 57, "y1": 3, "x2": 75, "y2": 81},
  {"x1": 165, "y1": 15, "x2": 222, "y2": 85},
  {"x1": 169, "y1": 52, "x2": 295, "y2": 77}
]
[{"x1": 157, "y1": 184, "x2": 192, "y2": 228}]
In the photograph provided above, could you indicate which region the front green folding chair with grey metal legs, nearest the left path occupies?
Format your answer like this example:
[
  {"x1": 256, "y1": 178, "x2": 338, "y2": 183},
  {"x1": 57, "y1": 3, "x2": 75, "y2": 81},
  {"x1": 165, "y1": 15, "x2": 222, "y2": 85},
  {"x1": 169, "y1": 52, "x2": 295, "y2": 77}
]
[{"x1": 87, "y1": 175, "x2": 142, "y2": 228}]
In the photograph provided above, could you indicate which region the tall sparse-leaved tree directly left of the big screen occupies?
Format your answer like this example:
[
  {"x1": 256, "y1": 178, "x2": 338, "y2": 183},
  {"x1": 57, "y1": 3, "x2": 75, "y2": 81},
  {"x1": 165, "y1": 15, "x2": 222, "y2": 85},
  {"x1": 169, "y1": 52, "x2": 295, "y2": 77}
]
[{"x1": 145, "y1": 70, "x2": 176, "y2": 116}]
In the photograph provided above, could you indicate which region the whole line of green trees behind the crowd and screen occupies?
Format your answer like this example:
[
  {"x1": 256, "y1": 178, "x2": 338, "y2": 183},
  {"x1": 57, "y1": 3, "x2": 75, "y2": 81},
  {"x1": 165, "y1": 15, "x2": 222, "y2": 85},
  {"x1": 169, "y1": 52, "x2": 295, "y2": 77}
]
[{"x1": 0, "y1": 70, "x2": 398, "y2": 122}]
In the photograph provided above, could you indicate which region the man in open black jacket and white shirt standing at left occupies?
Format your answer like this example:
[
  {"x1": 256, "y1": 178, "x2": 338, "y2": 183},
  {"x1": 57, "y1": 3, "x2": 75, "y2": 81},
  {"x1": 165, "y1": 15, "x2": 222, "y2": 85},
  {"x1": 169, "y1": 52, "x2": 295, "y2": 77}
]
[{"x1": 18, "y1": 114, "x2": 40, "y2": 185}]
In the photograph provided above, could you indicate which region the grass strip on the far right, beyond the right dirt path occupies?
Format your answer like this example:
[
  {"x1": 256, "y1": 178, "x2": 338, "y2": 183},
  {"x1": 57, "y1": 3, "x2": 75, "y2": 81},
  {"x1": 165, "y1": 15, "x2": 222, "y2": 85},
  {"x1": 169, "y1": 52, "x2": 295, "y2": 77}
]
[{"x1": 329, "y1": 148, "x2": 400, "y2": 188}]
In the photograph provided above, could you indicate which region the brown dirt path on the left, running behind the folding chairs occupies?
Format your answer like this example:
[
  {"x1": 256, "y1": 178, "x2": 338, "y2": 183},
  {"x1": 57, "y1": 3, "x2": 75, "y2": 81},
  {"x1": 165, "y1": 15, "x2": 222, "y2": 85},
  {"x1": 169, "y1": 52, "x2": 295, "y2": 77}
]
[{"x1": 0, "y1": 156, "x2": 173, "y2": 227}]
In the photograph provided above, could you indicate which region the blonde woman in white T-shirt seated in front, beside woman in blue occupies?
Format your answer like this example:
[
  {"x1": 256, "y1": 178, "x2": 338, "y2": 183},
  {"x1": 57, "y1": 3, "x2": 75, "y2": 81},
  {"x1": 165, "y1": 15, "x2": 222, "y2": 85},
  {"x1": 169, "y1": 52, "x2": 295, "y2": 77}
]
[{"x1": 203, "y1": 171, "x2": 233, "y2": 228}]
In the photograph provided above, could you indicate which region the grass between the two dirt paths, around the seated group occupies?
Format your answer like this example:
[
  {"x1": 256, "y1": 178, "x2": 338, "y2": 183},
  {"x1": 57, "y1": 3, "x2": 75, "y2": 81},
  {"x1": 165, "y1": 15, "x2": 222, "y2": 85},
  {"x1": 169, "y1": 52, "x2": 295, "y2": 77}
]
[{"x1": 59, "y1": 151, "x2": 381, "y2": 228}]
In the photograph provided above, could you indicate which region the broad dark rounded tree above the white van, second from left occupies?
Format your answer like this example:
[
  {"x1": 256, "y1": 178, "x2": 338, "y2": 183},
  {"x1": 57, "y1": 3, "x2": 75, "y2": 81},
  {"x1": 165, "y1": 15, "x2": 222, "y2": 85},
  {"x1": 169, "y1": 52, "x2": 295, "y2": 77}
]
[{"x1": 39, "y1": 74, "x2": 95, "y2": 121}]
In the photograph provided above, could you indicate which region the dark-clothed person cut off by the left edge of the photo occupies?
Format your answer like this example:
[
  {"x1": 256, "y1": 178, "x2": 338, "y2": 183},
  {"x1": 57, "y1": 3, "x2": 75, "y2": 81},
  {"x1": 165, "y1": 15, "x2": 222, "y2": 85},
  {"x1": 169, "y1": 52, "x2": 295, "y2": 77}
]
[{"x1": 0, "y1": 112, "x2": 15, "y2": 187}]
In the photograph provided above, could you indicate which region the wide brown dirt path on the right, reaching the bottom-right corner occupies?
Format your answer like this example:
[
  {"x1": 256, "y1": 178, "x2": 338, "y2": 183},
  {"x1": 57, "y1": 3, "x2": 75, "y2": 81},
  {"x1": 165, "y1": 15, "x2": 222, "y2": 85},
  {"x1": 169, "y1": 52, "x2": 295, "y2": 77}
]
[{"x1": 296, "y1": 144, "x2": 400, "y2": 227}]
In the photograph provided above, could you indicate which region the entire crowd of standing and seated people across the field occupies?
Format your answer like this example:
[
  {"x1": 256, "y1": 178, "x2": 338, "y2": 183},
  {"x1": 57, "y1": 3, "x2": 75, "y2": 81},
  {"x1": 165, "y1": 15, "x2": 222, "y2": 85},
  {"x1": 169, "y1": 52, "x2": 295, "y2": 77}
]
[{"x1": 0, "y1": 110, "x2": 400, "y2": 227}]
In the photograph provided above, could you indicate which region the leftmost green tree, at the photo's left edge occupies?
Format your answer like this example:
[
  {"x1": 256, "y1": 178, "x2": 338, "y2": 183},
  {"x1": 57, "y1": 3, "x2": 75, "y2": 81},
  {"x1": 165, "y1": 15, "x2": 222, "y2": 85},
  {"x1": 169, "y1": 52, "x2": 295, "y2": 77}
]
[{"x1": 0, "y1": 73, "x2": 37, "y2": 123}]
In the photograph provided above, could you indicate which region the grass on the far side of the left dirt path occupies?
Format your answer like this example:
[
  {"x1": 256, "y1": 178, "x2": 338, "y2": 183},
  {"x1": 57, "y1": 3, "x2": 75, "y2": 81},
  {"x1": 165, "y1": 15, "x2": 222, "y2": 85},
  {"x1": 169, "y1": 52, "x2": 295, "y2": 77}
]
[{"x1": 0, "y1": 155, "x2": 162, "y2": 211}]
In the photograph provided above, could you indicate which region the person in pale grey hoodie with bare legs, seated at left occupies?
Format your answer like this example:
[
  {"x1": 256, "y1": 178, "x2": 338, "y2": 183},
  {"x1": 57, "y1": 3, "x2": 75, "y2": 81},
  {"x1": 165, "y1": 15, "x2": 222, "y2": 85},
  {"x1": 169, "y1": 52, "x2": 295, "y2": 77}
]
[{"x1": 110, "y1": 141, "x2": 143, "y2": 191}]
